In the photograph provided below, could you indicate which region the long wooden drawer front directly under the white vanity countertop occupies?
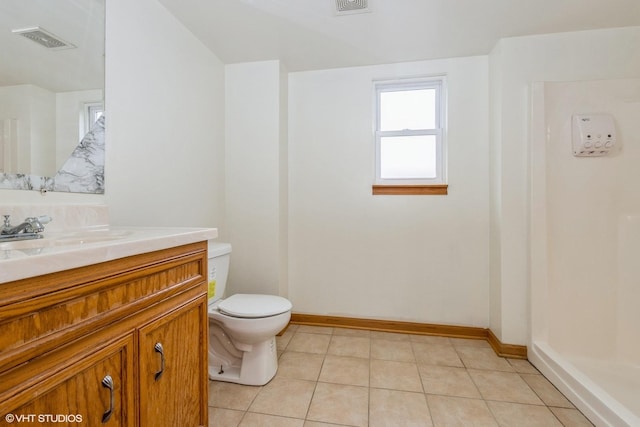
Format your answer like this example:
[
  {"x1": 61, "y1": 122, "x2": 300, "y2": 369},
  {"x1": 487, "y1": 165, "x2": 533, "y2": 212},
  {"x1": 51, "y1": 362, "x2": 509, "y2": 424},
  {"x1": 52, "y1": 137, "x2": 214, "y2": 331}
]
[{"x1": 0, "y1": 245, "x2": 206, "y2": 370}]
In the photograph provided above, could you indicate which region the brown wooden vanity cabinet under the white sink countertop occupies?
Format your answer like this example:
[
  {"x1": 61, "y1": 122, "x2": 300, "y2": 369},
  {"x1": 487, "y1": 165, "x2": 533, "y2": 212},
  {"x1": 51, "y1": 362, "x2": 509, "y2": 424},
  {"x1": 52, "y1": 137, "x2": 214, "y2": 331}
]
[{"x1": 0, "y1": 242, "x2": 208, "y2": 427}]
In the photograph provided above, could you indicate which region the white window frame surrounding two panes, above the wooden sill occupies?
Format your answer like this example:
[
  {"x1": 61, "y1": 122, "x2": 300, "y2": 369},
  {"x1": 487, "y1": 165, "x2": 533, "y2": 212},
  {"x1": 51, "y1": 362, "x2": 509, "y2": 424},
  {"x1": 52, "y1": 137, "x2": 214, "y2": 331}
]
[{"x1": 374, "y1": 76, "x2": 446, "y2": 186}]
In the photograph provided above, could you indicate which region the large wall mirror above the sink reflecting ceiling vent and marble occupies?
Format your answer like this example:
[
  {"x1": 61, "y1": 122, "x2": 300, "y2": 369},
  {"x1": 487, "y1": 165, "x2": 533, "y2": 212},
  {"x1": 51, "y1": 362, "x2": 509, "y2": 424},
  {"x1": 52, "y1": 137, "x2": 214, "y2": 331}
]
[{"x1": 0, "y1": 0, "x2": 105, "y2": 193}]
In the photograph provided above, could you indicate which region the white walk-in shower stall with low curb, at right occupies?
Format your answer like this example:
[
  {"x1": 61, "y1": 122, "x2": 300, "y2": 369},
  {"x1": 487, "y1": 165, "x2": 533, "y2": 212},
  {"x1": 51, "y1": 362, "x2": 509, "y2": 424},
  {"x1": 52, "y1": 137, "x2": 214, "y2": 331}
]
[{"x1": 529, "y1": 79, "x2": 640, "y2": 426}]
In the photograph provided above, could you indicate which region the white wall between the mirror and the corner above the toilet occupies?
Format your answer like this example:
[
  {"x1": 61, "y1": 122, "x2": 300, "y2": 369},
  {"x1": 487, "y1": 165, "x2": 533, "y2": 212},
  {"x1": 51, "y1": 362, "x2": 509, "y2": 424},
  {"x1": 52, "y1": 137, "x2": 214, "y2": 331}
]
[{"x1": 105, "y1": 0, "x2": 224, "y2": 228}]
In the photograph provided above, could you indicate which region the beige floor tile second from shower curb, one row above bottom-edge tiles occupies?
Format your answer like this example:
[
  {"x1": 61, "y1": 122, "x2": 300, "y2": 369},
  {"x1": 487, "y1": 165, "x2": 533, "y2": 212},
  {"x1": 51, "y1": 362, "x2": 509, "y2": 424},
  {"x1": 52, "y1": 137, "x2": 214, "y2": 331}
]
[{"x1": 468, "y1": 369, "x2": 543, "y2": 405}]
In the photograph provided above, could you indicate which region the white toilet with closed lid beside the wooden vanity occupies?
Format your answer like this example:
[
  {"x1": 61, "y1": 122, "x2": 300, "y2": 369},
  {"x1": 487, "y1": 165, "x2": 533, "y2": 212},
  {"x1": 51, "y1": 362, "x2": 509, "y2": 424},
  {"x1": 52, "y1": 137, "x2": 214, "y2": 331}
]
[{"x1": 208, "y1": 241, "x2": 291, "y2": 385}]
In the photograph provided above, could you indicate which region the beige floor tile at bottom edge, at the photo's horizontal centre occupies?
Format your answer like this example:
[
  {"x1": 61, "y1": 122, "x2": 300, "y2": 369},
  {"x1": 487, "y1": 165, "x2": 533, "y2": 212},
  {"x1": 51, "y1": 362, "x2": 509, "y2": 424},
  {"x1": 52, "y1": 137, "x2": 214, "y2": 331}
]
[{"x1": 307, "y1": 383, "x2": 369, "y2": 427}]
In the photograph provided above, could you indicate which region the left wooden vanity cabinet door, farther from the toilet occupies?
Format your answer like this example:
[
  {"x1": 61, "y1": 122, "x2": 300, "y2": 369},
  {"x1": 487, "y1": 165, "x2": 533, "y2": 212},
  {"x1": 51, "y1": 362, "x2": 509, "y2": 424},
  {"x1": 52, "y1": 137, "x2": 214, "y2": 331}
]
[{"x1": 0, "y1": 335, "x2": 135, "y2": 427}]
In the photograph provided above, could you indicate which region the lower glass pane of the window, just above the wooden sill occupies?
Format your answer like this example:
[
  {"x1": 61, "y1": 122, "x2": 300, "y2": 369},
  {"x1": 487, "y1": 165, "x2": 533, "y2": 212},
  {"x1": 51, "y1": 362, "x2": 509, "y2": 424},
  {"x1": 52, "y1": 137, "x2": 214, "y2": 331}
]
[{"x1": 380, "y1": 135, "x2": 436, "y2": 179}]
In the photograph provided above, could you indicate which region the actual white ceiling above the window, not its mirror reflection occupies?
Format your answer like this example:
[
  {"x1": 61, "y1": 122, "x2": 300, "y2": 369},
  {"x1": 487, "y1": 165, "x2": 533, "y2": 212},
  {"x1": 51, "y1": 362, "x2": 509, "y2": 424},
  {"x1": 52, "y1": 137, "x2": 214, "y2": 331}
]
[{"x1": 159, "y1": 0, "x2": 640, "y2": 71}]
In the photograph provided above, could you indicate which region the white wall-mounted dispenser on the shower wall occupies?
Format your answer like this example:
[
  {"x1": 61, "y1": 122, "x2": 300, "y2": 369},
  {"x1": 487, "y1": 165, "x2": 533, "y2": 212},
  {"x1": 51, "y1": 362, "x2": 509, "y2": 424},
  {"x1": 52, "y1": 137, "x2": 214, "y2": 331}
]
[{"x1": 572, "y1": 114, "x2": 616, "y2": 157}]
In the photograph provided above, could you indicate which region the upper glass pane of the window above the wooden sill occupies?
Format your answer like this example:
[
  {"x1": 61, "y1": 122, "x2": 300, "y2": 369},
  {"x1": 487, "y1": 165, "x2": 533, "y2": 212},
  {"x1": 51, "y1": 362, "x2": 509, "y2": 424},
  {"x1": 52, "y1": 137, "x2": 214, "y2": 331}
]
[{"x1": 379, "y1": 89, "x2": 436, "y2": 131}]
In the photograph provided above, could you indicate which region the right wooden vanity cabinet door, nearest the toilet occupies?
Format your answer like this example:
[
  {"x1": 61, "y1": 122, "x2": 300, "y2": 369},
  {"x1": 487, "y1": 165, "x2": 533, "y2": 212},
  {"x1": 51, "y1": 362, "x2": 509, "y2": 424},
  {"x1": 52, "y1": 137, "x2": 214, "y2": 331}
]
[{"x1": 138, "y1": 295, "x2": 208, "y2": 427}]
